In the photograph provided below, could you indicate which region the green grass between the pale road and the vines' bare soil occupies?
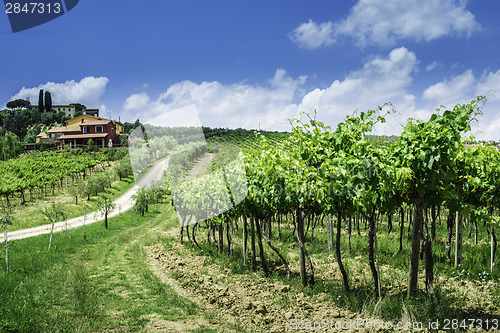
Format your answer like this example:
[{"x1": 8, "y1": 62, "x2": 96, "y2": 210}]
[{"x1": 0, "y1": 198, "x2": 230, "y2": 332}]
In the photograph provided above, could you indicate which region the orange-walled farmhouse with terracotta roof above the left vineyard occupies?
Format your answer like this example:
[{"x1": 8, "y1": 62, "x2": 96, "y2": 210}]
[{"x1": 36, "y1": 114, "x2": 123, "y2": 148}]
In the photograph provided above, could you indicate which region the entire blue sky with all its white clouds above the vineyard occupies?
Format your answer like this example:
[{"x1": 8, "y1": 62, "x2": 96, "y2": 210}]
[{"x1": 0, "y1": 0, "x2": 500, "y2": 140}]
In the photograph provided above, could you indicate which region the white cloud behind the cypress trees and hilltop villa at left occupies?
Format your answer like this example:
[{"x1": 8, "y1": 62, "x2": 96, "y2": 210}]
[{"x1": 11, "y1": 76, "x2": 109, "y2": 108}]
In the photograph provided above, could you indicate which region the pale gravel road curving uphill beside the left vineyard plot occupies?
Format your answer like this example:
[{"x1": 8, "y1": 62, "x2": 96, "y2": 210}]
[{"x1": 0, "y1": 158, "x2": 168, "y2": 243}]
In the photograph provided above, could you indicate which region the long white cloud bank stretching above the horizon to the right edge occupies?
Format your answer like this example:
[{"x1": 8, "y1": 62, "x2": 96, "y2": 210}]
[{"x1": 122, "y1": 47, "x2": 500, "y2": 140}]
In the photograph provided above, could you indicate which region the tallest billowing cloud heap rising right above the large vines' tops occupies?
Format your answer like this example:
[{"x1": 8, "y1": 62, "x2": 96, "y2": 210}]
[{"x1": 300, "y1": 47, "x2": 429, "y2": 134}]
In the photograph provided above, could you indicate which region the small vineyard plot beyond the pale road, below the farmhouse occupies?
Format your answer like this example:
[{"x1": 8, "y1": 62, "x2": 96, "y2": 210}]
[{"x1": 0, "y1": 151, "x2": 134, "y2": 231}]
